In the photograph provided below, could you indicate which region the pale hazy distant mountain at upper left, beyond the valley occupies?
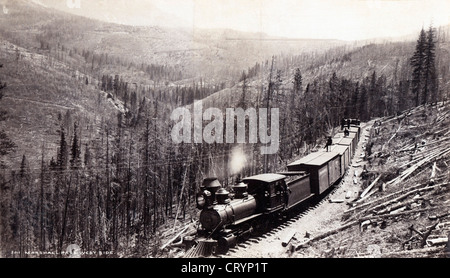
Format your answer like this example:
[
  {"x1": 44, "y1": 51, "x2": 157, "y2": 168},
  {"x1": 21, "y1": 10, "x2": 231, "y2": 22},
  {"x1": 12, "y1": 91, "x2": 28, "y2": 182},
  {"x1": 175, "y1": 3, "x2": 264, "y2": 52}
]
[{"x1": 0, "y1": 0, "x2": 346, "y2": 80}]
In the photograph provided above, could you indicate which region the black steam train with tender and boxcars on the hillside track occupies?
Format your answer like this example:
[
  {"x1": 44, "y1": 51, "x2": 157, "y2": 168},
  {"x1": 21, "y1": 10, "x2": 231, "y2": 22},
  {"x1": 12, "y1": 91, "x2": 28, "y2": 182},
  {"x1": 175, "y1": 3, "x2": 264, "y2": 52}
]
[{"x1": 186, "y1": 119, "x2": 361, "y2": 253}]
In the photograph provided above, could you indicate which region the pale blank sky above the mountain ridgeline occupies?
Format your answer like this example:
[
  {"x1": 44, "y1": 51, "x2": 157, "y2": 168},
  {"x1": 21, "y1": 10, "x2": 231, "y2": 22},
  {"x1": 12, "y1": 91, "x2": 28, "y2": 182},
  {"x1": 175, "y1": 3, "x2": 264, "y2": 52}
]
[{"x1": 39, "y1": 0, "x2": 450, "y2": 40}]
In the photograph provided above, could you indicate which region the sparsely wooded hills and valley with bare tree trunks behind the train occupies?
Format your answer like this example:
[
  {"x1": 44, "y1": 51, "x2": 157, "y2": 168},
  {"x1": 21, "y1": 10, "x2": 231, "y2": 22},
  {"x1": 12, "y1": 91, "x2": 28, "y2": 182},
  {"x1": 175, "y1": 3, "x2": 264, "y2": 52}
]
[{"x1": 0, "y1": 1, "x2": 450, "y2": 257}]
